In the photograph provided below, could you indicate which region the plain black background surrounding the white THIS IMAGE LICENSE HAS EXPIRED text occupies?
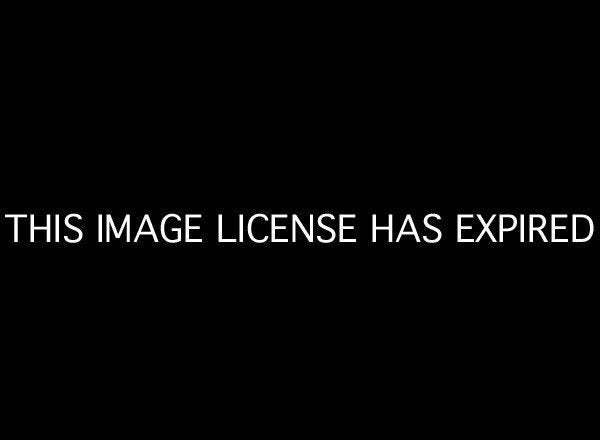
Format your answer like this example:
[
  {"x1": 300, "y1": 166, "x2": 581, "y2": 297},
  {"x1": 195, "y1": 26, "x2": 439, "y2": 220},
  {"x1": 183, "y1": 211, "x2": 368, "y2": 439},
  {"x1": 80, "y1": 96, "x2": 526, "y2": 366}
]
[{"x1": 1, "y1": 5, "x2": 598, "y2": 433}]
